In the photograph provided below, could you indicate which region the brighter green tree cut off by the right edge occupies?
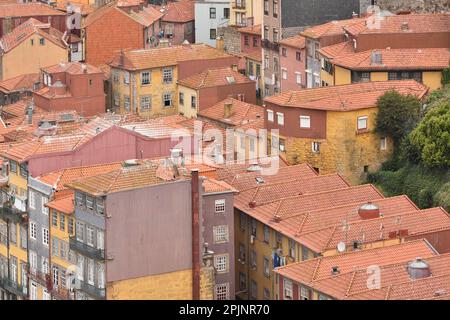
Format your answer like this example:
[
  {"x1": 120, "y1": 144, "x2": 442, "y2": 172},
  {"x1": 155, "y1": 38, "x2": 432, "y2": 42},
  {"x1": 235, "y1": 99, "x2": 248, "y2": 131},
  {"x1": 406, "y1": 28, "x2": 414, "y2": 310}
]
[{"x1": 408, "y1": 99, "x2": 450, "y2": 168}]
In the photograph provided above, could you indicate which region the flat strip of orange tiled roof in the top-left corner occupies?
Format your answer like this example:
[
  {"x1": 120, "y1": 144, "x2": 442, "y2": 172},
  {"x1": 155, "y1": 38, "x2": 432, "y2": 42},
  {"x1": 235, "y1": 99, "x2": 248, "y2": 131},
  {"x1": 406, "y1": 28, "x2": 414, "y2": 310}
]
[{"x1": 0, "y1": 2, "x2": 65, "y2": 18}]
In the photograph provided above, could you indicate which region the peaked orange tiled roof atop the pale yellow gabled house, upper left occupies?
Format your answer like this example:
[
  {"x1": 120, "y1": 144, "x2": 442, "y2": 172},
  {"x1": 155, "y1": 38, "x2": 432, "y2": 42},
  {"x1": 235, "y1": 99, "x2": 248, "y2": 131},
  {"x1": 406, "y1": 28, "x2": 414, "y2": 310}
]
[{"x1": 0, "y1": 17, "x2": 67, "y2": 52}]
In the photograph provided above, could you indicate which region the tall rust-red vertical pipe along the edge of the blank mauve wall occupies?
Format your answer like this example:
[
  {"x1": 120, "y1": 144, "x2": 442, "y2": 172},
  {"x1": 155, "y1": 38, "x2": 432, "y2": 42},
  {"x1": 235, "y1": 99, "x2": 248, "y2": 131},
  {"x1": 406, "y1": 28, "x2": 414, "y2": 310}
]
[{"x1": 191, "y1": 169, "x2": 200, "y2": 300}]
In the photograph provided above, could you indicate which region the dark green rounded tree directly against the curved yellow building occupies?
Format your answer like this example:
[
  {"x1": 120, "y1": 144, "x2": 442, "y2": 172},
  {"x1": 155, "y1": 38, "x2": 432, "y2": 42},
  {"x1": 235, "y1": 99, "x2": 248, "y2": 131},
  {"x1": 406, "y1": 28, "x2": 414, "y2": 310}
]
[{"x1": 375, "y1": 90, "x2": 421, "y2": 146}]
